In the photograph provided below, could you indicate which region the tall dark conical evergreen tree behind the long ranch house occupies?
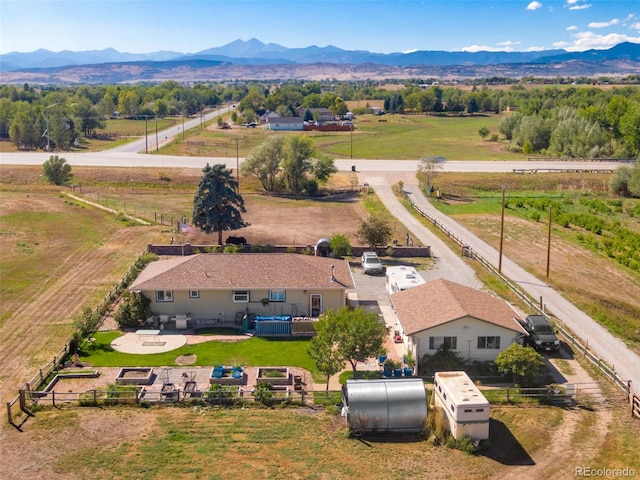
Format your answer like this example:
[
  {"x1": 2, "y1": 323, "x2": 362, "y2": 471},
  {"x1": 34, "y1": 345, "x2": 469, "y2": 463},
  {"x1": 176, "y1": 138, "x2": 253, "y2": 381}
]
[{"x1": 193, "y1": 164, "x2": 249, "y2": 245}]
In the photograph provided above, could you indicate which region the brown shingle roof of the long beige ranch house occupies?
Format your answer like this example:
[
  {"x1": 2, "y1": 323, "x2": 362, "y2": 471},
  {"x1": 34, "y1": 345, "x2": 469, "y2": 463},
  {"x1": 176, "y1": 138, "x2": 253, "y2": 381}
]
[{"x1": 129, "y1": 253, "x2": 354, "y2": 291}]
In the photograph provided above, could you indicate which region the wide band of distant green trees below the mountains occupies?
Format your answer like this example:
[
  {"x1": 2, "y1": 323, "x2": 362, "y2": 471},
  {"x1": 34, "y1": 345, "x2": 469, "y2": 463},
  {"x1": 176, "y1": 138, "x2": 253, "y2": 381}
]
[{"x1": 0, "y1": 75, "x2": 640, "y2": 158}]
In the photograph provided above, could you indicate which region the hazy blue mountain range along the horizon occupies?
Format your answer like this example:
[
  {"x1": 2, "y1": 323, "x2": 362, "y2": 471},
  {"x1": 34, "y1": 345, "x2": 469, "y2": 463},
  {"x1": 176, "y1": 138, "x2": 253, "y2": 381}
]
[{"x1": 0, "y1": 38, "x2": 640, "y2": 84}]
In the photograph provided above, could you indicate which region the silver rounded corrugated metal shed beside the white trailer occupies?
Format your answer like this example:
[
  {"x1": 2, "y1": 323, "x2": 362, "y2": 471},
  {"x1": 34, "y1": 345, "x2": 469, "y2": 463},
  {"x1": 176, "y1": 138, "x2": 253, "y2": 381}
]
[{"x1": 342, "y1": 378, "x2": 427, "y2": 433}]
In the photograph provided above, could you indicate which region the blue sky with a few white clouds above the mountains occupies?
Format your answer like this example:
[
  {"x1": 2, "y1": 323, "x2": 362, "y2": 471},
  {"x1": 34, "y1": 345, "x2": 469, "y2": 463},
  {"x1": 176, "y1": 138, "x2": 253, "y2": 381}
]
[{"x1": 0, "y1": 0, "x2": 640, "y2": 53}]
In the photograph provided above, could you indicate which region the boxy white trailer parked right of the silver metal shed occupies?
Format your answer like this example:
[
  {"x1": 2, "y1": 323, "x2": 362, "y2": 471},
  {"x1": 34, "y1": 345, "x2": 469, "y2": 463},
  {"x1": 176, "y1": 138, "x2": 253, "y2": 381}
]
[{"x1": 433, "y1": 372, "x2": 489, "y2": 440}]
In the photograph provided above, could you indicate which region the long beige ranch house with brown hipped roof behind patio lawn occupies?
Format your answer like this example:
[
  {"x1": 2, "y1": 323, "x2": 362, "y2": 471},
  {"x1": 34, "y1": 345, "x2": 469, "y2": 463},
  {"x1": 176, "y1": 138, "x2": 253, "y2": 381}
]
[{"x1": 129, "y1": 253, "x2": 354, "y2": 328}]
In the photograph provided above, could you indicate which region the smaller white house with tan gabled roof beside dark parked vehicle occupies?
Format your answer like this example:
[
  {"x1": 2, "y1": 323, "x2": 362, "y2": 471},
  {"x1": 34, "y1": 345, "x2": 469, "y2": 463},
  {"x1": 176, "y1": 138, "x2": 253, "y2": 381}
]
[{"x1": 390, "y1": 279, "x2": 527, "y2": 368}]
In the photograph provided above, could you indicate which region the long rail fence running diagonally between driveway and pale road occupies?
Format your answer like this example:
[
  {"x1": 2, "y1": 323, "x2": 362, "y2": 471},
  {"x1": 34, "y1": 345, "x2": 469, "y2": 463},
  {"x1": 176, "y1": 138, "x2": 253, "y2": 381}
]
[{"x1": 407, "y1": 198, "x2": 632, "y2": 401}]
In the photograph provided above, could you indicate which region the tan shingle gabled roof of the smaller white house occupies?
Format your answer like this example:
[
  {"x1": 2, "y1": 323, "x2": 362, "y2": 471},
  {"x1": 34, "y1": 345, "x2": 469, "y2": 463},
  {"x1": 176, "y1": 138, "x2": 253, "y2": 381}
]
[{"x1": 391, "y1": 279, "x2": 526, "y2": 335}]
